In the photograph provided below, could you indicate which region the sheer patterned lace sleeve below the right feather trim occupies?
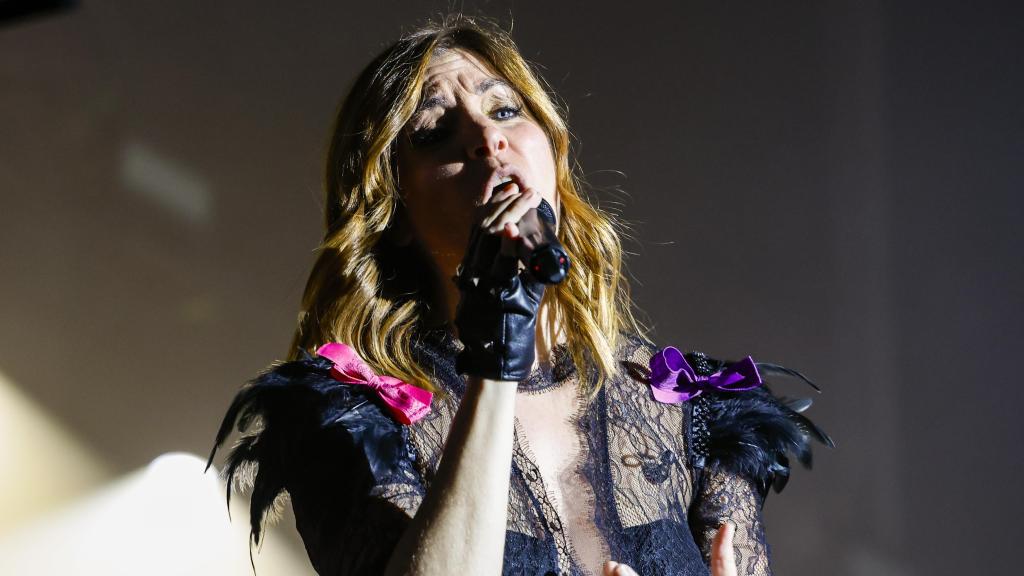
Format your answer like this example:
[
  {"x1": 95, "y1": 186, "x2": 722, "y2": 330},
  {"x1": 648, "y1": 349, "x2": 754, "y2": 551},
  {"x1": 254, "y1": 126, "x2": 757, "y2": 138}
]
[{"x1": 691, "y1": 468, "x2": 771, "y2": 576}]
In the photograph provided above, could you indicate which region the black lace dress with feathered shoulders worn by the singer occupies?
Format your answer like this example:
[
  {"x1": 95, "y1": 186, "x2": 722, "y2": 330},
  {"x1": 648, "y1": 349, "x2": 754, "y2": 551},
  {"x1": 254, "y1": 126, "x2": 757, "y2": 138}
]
[{"x1": 210, "y1": 330, "x2": 830, "y2": 576}]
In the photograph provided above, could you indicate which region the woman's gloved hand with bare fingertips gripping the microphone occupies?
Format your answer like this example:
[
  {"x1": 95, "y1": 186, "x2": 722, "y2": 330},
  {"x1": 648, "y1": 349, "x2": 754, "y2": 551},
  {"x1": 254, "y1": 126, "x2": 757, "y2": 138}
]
[{"x1": 455, "y1": 182, "x2": 544, "y2": 381}]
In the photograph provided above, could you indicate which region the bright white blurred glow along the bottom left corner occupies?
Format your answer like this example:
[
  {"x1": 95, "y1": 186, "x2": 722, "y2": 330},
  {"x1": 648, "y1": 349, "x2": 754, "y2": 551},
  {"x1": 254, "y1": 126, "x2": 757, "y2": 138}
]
[{"x1": 0, "y1": 454, "x2": 313, "y2": 576}]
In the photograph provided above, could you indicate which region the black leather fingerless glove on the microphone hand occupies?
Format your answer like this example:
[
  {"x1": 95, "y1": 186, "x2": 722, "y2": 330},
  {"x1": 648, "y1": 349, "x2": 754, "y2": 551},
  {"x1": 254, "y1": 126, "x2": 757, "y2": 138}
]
[{"x1": 454, "y1": 213, "x2": 544, "y2": 382}]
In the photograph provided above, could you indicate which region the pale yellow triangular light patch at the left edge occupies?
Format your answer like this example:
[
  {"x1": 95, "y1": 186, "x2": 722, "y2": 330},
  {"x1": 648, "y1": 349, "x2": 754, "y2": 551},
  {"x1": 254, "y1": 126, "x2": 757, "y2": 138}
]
[{"x1": 0, "y1": 366, "x2": 112, "y2": 532}]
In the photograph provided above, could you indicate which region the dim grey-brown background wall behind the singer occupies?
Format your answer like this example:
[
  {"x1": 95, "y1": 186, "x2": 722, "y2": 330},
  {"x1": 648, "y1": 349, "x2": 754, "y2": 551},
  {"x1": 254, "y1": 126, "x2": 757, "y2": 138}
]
[{"x1": 0, "y1": 0, "x2": 1024, "y2": 575}]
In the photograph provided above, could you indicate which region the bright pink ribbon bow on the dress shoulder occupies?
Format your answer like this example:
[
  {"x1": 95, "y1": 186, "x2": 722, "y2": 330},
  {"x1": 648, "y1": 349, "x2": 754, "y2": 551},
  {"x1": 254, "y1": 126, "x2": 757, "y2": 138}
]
[{"x1": 316, "y1": 342, "x2": 434, "y2": 425}]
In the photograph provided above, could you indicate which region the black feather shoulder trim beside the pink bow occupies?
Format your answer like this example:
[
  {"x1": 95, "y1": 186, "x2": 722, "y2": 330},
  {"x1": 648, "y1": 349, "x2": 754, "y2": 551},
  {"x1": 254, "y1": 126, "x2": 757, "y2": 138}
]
[{"x1": 207, "y1": 354, "x2": 410, "y2": 544}]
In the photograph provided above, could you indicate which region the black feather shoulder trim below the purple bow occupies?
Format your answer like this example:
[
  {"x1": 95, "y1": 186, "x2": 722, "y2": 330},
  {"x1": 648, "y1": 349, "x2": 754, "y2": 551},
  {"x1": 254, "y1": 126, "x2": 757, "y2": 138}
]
[{"x1": 685, "y1": 353, "x2": 836, "y2": 497}]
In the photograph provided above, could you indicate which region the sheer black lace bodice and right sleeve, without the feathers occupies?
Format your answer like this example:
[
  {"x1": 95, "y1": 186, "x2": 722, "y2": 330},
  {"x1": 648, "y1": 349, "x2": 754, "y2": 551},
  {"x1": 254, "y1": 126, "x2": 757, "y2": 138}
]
[{"x1": 393, "y1": 332, "x2": 770, "y2": 574}]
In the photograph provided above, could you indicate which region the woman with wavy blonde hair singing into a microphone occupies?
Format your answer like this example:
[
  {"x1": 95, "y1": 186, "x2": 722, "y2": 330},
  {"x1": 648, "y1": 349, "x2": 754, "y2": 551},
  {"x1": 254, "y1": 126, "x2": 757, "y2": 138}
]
[{"x1": 210, "y1": 14, "x2": 830, "y2": 576}]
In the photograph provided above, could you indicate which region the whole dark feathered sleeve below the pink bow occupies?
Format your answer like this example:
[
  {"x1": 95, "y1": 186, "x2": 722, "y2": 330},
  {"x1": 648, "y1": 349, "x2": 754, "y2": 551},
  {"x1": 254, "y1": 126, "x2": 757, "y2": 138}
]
[{"x1": 209, "y1": 357, "x2": 424, "y2": 576}]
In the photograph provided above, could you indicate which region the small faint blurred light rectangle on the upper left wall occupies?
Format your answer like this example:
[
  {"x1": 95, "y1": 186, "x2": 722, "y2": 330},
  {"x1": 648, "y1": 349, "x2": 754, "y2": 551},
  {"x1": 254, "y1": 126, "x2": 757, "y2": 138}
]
[{"x1": 121, "y1": 142, "x2": 213, "y2": 223}]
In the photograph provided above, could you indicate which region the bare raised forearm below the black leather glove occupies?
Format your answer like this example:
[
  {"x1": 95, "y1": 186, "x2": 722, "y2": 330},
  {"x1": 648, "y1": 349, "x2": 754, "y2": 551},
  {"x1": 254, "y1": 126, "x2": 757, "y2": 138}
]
[{"x1": 387, "y1": 377, "x2": 516, "y2": 576}]
